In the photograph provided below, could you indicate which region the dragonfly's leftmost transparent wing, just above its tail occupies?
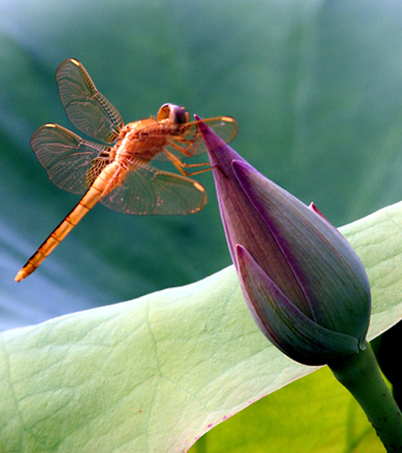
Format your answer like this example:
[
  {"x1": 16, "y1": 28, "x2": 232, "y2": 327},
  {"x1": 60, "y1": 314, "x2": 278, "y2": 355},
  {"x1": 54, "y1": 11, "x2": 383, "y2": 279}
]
[{"x1": 31, "y1": 124, "x2": 111, "y2": 193}]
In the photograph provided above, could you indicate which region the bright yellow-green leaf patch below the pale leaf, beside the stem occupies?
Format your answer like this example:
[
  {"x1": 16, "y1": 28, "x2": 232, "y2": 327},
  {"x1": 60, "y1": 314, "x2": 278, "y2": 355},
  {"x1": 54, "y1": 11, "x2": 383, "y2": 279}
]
[{"x1": 189, "y1": 367, "x2": 385, "y2": 453}]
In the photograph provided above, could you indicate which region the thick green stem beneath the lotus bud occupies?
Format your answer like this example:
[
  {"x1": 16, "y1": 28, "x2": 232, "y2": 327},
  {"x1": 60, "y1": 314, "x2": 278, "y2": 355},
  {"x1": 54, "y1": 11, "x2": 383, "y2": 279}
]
[{"x1": 329, "y1": 342, "x2": 402, "y2": 453}]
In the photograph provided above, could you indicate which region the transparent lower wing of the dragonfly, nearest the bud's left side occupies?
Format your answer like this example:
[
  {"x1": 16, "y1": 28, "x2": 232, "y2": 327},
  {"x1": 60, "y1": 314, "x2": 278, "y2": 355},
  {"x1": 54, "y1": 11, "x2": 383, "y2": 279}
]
[{"x1": 101, "y1": 164, "x2": 206, "y2": 215}]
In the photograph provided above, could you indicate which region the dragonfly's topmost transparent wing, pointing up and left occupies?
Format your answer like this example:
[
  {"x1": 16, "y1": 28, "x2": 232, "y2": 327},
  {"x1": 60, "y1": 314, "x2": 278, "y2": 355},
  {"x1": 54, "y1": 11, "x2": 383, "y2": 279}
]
[{"x1": 56, "y1": 59, "x2": 123, "y2": 143}]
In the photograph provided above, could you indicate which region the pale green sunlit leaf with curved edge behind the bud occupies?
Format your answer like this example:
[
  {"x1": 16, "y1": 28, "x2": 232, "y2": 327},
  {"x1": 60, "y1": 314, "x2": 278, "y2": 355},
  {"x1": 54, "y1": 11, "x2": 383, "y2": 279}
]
[{"x1": 0, "y1": 203, "x2": 402, "y2": 453}]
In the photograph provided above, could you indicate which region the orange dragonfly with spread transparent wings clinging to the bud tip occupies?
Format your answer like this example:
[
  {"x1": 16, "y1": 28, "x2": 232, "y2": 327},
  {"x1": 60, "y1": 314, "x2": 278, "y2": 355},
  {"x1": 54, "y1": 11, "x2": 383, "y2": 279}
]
[{"x1": 15, "y1": 59, "x2": 237, "y2": 282}]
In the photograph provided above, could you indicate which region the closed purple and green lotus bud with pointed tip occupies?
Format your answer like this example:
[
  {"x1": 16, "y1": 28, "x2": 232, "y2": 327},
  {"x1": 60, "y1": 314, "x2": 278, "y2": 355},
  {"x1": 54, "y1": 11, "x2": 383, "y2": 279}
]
[{"x1": 200, "y1": 118, "x2": 370, "y2": 365}]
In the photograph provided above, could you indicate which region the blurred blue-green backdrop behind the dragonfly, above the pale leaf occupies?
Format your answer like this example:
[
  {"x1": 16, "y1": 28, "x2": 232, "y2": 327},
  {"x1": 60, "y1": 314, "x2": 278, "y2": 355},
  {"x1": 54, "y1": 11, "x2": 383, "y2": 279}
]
[{"x1": 0, "y1": 0, "x2": 402, "y2": 452}]
